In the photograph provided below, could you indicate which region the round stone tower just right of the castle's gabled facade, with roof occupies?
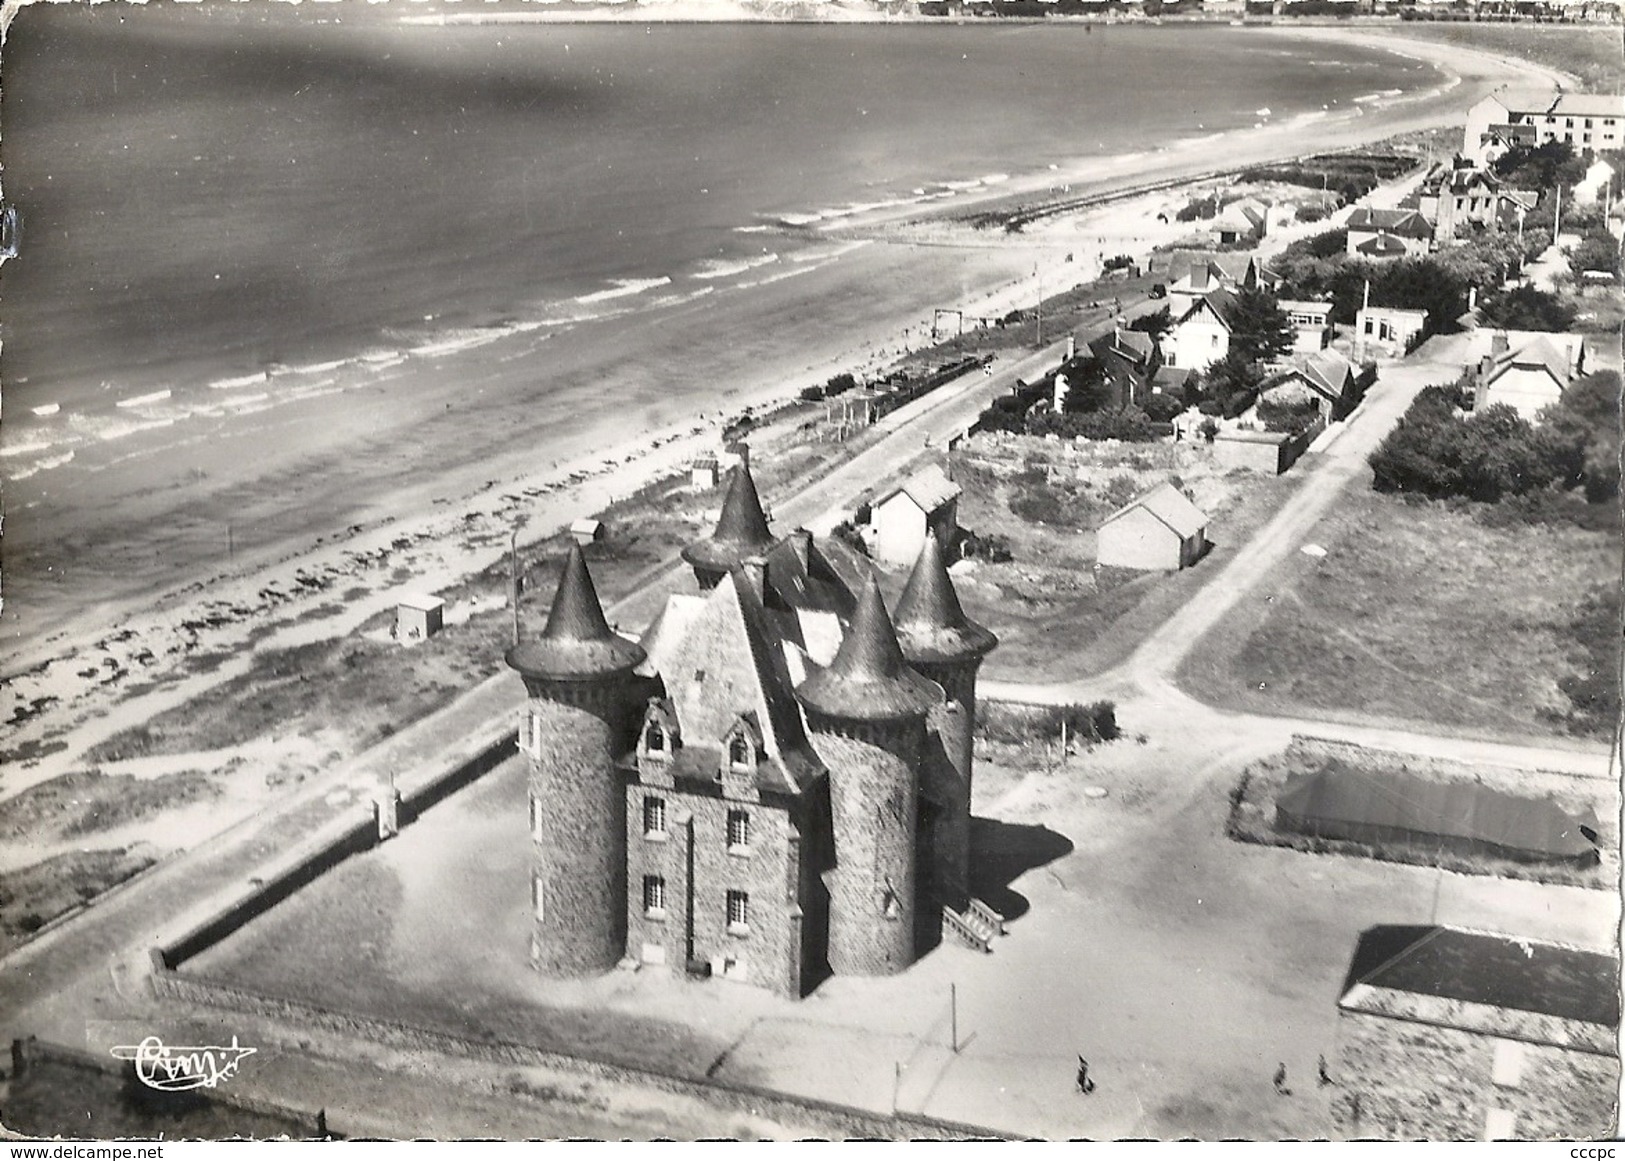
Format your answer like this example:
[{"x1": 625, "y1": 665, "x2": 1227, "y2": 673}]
[{"x1": 796, "y1": 577, "x2": 941, "y2": 976}]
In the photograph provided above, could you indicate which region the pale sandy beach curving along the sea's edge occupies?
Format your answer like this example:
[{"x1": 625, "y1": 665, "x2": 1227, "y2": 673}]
[{"x1": 0, "y1": 20, "x2": 1573, "y2": 794}]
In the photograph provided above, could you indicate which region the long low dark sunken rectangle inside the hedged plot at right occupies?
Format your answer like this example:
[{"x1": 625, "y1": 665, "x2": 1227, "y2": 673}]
[{"x1": 1276, "y1": 758, "x2": 1597, "y2": 865}]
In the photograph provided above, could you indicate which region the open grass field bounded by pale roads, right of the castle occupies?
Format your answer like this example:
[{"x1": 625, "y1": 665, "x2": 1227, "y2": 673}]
[{"x1": 1180, "y1": 493, "x2": 1620, "y2": 737}]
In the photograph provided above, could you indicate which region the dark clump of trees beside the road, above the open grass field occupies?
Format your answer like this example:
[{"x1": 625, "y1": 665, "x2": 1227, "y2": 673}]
[{"x1": 1370, "y1": 371, "x2": 1620, "y2": 504}]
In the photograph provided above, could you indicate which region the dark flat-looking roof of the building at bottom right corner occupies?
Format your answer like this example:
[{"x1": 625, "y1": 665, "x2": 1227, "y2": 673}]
[{"x1": 1342, "y1": 925, "x2": 1620, "y2": 1028}]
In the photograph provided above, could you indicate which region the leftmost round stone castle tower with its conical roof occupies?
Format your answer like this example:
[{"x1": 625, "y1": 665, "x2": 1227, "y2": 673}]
[{"x1": 507, "y1": 545, "x2": 644, "y2": 976}]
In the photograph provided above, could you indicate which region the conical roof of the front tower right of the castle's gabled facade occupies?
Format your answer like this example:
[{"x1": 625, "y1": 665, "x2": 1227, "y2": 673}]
[{"x1": 796, "y1": 577, "x2": 943, "y2": 722}]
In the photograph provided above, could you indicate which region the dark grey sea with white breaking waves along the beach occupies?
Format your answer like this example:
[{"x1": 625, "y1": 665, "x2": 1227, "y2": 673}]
[{"x1": 0, "y1": 0, "x2": 1437, "y2": 480}]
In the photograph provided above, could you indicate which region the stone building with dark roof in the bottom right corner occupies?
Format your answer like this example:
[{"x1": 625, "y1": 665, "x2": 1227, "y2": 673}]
[{"x1": 1333, "y1": 924, "x2": 1620, "y2": 1140}]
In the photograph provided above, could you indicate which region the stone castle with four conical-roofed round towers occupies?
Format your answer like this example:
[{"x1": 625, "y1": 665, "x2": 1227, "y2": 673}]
[{"x1": 507, "y1": 465, "x2": 999, "y2": 997}]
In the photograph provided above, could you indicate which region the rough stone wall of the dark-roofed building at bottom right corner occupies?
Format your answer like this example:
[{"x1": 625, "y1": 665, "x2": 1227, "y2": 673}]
[{"x1": 1333, "y1": 1010, "x2": 1619, "y2": 1140}]
